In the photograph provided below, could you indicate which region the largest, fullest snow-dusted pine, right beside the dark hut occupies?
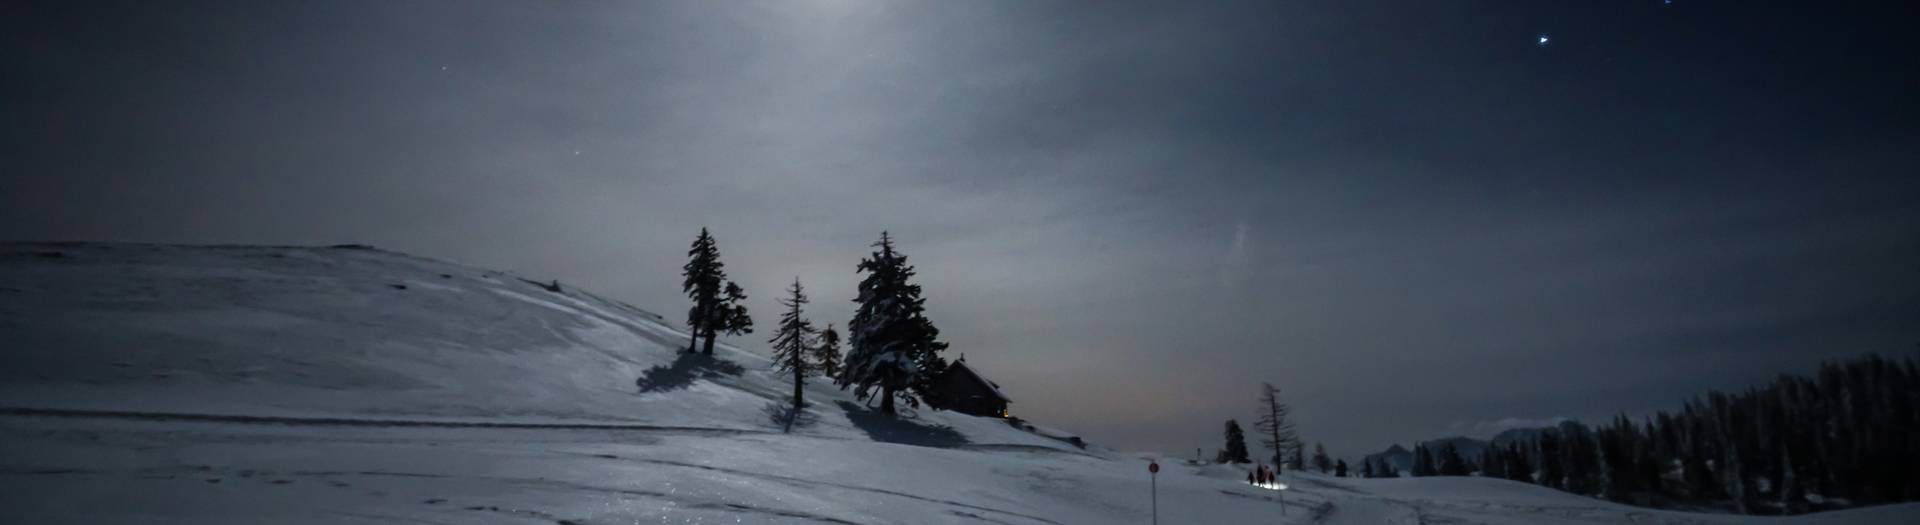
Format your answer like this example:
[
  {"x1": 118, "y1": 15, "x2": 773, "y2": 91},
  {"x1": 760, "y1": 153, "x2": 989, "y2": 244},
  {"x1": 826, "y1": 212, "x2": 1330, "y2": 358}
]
[{"x1": 839, "y1": 233, "x2": 947, "y2": 415}]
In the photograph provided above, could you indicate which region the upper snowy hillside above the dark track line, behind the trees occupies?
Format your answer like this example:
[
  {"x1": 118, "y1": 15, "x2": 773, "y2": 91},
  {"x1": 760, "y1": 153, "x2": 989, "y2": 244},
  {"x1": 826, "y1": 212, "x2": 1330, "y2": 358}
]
[{"x1": 0, "y1": 244, "x2": 1082, "y2": 446}]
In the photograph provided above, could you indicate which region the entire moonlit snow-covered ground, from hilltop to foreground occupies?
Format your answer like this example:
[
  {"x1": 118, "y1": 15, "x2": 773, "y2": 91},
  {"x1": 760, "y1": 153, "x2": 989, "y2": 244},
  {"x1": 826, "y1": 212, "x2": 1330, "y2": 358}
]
[{"x1": 0, "y1": 244, "x2": 1920, "y2": 523}]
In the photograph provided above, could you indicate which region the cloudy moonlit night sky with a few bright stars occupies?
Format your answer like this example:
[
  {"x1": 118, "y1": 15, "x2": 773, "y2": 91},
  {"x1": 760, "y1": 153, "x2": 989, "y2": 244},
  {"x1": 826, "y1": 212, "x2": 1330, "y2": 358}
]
[{"x1": 0, "y1": 0, "x2": 1920, "y2": 458}]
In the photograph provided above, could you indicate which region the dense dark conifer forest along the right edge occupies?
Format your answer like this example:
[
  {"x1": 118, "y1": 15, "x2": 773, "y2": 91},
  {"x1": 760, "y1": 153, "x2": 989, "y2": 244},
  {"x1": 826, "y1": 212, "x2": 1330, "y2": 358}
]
[{"x1": 1361, "y1": 356, "x2": 1920, "y2": 513}]
